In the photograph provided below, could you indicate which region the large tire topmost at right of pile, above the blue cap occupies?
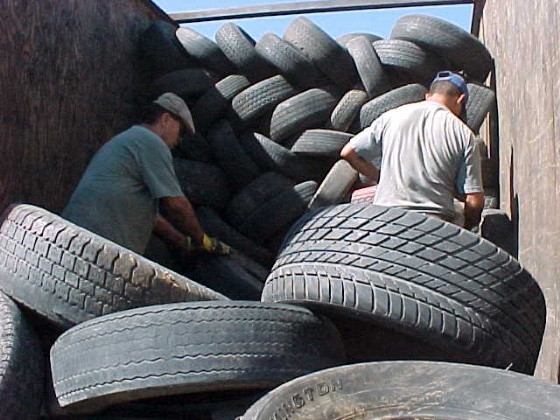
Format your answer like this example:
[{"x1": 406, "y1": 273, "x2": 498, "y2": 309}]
[{"x1": 391, "y1": 14, "x2": 492, "y2": 82}]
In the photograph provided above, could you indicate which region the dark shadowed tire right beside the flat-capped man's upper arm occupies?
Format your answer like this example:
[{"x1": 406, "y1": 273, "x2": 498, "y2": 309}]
[{"x1": 173, "y1": 158, "x2": 230, "y2": 209}]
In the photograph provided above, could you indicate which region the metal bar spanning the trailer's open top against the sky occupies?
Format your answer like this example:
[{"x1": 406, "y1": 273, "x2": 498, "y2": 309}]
[{"x1": 169, "y1": 0, "x2": 475, "y2": 23}]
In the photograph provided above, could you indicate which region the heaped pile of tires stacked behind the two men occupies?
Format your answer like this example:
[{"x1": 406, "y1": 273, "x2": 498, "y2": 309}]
[{"x1": 139, "y1": 15, "x2": 495, "y2": 276}]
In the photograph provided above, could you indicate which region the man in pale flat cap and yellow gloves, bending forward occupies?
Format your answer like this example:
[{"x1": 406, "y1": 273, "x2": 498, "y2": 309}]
[{"x1": 62, "y1": 93, "x2": 229, "y2": 254}]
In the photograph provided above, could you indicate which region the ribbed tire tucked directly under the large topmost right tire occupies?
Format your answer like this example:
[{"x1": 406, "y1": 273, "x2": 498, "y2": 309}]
[{"x1": 373, "y1": 39, "x2": 448, "y2": 85}]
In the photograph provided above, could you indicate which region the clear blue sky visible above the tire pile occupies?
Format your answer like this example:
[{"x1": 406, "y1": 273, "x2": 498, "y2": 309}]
[{"x1": 153, "y1": 0, "x2": 473, "y2": 40}]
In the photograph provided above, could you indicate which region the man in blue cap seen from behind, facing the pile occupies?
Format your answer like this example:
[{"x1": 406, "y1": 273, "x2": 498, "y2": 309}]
[{"x1": 341, "y1": 71, "x2": 484, "y2": 229}]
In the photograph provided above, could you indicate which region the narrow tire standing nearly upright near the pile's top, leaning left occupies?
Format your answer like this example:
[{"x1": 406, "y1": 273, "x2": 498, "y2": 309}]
[{"x1": 346, "y1": 36, "x2": 391, "y2": 98}]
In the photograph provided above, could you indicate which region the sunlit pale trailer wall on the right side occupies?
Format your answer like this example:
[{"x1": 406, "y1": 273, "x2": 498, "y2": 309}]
[{"x1": 481, "y1": 0, "x2": 560, "y2": 382}]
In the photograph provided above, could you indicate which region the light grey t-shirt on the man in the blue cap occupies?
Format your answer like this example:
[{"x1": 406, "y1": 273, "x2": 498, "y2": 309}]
[{"x1": 350, "y1": 101, "x2": 483, "y2": 219}]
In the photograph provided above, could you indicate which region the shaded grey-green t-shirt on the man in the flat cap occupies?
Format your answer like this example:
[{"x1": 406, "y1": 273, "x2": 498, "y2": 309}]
[{"x1": 62, "y1": 125, "x2": 183, "y2": 254}]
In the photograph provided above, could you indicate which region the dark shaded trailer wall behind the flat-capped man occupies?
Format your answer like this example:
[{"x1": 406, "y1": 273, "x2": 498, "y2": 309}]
[{"x1": 0, "y1": 0, "x2": 166, "y2": 211}]
